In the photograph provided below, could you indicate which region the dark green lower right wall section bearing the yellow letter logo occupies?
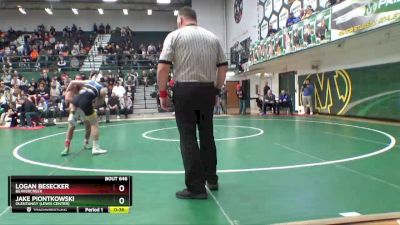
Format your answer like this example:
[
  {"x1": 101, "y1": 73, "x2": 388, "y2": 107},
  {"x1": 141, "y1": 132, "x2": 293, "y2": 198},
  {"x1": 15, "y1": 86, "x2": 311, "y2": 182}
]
[{"x1": 298, "y1": 62, "x2": 400, "y2": 120}]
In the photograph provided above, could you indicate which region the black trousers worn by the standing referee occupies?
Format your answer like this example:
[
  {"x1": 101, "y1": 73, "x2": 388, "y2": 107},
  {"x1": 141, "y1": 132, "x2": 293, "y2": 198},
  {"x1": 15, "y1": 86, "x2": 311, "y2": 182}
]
[{"x1": 174, "y1": 82, "x2": 218, "y2": 193}]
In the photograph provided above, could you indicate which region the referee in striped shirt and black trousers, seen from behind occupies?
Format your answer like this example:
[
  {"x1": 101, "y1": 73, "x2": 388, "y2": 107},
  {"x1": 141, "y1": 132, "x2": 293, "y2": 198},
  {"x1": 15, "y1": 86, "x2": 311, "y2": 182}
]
[{"x1": 158, "y1": 7, "x2": 228, "y2": 199}]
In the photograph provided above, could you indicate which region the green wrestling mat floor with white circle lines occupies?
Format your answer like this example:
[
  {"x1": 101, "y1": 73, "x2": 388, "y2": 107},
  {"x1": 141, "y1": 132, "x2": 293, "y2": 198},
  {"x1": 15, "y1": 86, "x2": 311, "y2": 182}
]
[{"x1": 0, "y1": 116, "x2": 400, "y2": 225}]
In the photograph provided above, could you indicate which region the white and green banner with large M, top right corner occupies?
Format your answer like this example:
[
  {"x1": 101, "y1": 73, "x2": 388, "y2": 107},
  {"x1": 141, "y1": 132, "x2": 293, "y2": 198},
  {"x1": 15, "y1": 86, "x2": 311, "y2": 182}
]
[{"x1": 332, "y1": 0, "x2": 400, "y2": 40}]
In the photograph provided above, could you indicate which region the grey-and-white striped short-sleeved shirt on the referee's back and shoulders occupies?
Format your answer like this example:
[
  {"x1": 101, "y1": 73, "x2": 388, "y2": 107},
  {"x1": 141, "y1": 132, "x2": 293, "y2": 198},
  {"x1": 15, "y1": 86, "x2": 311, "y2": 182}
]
[{"x1": 159, "y1": 25, "x2": 228, "y2": 83}]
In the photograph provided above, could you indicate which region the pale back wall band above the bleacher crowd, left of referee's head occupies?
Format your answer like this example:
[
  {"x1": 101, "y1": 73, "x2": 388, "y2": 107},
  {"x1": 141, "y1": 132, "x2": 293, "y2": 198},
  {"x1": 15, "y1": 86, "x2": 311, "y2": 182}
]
[{"x1": 0, "y1": 9, "x2": 176, "y2": 31}]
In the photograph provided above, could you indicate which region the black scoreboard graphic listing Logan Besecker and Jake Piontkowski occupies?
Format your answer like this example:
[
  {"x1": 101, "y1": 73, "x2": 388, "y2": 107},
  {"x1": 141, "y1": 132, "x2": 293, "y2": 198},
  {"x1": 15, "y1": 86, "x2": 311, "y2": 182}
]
[{"x1": 8, "y1": 176, "x2": 132, "y2": 214}]
